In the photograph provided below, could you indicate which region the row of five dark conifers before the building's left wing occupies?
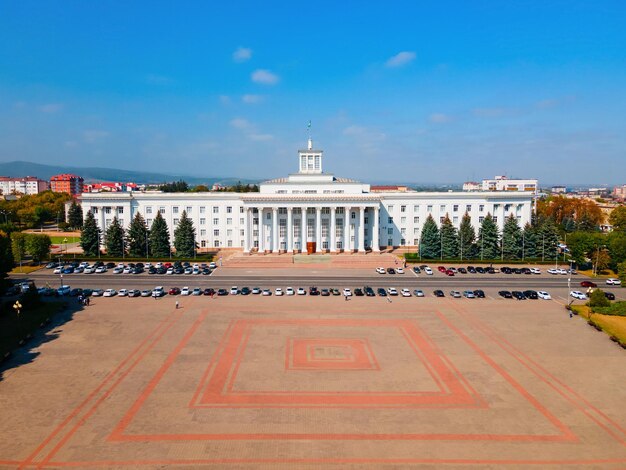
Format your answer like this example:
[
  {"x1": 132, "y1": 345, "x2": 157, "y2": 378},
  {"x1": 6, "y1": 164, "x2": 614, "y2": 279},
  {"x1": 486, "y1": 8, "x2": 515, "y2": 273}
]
[{"x1": 80, "y1": 211, "x2": 197, "y2": 258}]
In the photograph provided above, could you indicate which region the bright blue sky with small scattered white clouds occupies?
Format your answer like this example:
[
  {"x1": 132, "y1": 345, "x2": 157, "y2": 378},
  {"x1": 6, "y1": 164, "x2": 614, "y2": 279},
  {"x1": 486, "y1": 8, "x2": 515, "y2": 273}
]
[{"x1": 0, "y1": 0, "x2": 626, "y2": 184}]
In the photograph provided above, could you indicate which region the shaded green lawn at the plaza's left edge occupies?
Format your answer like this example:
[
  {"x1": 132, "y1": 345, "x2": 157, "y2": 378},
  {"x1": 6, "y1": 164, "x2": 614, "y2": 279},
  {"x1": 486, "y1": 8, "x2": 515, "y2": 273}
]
[{"x1": 0, "y1": 302, "x2": 63, "y2": 359}]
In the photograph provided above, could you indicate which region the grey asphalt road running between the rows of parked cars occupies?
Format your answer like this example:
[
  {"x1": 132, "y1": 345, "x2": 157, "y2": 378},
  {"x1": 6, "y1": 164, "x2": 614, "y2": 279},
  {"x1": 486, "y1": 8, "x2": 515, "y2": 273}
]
[{"x1": 14, "y1": 268, "x2": 626, "y2": 298}]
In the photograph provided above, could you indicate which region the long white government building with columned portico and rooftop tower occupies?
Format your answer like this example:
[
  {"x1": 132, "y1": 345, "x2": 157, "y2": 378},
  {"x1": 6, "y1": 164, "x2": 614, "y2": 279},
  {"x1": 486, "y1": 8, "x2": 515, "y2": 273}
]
[{"x1": 80, "y1": 139, "x2": 534, "y2": 253}]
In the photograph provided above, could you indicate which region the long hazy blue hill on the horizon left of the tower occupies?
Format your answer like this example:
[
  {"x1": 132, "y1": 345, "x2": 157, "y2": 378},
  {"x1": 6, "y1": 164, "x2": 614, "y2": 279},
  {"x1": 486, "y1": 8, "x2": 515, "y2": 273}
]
[{"x1": 0, "y1": 161, "x2": 256, "y2": 186}]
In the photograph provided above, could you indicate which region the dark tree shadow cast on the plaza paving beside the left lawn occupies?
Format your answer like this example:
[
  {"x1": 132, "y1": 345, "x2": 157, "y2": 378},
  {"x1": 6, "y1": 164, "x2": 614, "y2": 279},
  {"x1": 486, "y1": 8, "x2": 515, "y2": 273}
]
[{"x1": 0, "y1": 297, "x2": 86, "y2": 382}]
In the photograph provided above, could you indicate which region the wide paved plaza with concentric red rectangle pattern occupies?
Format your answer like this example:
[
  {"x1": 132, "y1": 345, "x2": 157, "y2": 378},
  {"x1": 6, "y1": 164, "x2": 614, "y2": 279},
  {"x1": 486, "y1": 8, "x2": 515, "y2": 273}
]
[{"x1": 0, "y1": 296, "x2": 626, "y2": 469}]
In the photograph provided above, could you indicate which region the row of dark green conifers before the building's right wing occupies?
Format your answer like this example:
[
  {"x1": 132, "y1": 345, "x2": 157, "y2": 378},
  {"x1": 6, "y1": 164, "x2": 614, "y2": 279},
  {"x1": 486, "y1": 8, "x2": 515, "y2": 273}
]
[{"x1": 419, "y1": 213, "x2": 558, "y2": 260}]
